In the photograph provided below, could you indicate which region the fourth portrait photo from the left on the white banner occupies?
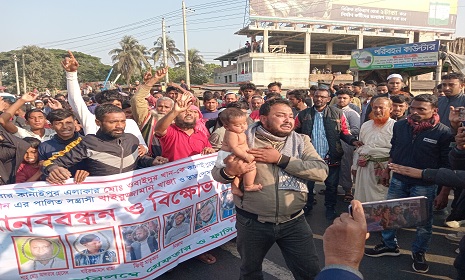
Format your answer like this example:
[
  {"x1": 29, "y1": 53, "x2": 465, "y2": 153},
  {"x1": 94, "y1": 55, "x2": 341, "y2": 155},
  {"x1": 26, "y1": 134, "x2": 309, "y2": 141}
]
[{"x1": 163, "y1": 206, "x2": 193, "y2": 248}]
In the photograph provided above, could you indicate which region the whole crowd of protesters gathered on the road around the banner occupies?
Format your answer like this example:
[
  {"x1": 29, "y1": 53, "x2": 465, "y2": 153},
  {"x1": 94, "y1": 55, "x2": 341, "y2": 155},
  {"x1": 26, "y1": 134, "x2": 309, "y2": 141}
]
[{"x1": 0, "y1": 49, "x2": 465, "y2": 279}]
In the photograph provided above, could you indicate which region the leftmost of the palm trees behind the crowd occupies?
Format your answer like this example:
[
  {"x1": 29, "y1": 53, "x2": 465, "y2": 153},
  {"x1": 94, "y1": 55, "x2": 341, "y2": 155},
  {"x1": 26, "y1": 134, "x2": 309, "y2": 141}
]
[{"x1": 108, "y1": 36, "x2": 150, "y2": 84}]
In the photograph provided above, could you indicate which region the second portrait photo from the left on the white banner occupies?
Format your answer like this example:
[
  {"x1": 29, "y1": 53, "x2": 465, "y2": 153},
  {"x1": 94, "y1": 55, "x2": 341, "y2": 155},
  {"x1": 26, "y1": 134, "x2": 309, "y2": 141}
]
[{"x1": 66, "y1": 227, "x2": 120, "y2": 267}]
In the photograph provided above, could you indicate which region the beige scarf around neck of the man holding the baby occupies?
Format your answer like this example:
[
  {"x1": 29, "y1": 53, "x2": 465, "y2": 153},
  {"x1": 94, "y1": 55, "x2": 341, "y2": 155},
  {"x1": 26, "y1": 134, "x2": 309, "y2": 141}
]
[{"x1": 246, "y1": 122, "x2": 308, "y2": 193}]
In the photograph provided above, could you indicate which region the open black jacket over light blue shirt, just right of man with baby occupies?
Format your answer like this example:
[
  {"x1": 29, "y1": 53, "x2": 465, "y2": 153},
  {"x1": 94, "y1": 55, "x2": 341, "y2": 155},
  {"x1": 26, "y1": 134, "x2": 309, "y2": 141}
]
[{"x1": 296, "y1": 106, "x2": 357, "y2": 163}]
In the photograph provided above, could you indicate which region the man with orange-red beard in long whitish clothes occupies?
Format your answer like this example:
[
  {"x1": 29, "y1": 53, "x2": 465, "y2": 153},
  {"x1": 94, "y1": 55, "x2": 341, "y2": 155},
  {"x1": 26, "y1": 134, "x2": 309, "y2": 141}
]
[{"x1": 352, "y1": 97, "x2": 396, "y2": 202}]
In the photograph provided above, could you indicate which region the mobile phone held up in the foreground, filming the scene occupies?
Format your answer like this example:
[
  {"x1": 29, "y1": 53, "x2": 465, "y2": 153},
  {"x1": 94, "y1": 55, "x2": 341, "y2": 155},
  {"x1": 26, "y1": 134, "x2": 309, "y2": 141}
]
[{"x1": 349, "y1": 196, "x2": 428, "y2": 232}]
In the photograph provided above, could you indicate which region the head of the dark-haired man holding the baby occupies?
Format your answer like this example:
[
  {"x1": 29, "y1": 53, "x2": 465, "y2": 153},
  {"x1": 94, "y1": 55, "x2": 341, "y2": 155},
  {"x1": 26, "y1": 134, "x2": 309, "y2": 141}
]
[{"x1": 260, "y1": 104, "x2": 294, "y2": 137}]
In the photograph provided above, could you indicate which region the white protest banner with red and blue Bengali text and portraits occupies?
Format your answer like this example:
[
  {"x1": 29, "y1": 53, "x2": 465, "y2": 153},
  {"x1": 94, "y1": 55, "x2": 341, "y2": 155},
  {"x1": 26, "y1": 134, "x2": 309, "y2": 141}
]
[{"x1": 0, "y1": 154, "x2": 236, "y2": 280}]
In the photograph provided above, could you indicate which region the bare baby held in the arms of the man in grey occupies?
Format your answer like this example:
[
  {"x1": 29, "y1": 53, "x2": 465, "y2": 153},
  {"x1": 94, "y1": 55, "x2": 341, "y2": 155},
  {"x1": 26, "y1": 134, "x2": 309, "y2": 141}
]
[{"x1": 215, "y1": 108, "x2": 262, "y2": 197}]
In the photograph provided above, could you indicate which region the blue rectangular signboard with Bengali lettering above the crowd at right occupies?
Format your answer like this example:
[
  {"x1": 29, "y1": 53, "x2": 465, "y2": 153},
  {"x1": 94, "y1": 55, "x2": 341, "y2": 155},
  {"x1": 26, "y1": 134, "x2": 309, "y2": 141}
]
[{"x1": 350, "y1": 41, "x2": 439, "y2": 71}]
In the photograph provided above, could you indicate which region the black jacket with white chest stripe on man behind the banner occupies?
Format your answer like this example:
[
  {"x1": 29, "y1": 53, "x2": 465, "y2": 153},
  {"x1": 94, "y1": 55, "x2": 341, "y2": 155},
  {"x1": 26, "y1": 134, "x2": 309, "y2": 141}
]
[{"x1": 43, "y1": 130, "x2": 154, "y2": 176}]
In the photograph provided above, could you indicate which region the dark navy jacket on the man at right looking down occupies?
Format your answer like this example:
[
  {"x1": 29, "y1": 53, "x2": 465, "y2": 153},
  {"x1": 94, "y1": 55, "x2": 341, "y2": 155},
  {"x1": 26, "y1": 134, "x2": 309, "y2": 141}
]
[{"x1": 390, "y1": 120, "x2": 453, "y2": 186}]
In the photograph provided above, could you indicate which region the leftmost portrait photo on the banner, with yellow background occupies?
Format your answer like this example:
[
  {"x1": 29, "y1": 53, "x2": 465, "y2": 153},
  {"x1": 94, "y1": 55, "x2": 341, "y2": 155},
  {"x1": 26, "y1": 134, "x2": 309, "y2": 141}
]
[{"x1": 11, "y1": 236, "x2": 68, "y2": 274}]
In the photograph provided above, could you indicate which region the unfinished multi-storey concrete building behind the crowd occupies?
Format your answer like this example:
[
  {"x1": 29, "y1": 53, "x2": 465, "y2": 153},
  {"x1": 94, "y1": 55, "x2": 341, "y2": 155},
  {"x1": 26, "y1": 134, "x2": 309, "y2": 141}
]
[{"x1": 214, "y1": 3, "x2": 455, "y2": 88}]
